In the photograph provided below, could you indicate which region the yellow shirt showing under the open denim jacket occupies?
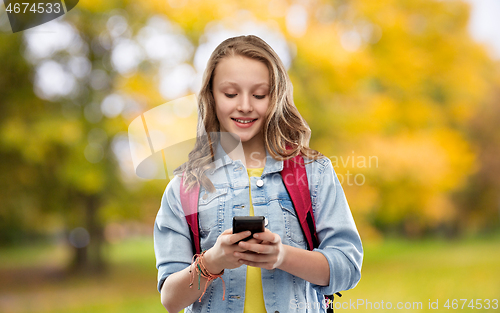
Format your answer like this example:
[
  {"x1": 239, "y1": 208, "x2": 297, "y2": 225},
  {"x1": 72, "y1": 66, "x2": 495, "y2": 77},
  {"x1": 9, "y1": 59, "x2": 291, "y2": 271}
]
[{"x1": 243, "y1": 168, "x2": 267, "y2": 313}]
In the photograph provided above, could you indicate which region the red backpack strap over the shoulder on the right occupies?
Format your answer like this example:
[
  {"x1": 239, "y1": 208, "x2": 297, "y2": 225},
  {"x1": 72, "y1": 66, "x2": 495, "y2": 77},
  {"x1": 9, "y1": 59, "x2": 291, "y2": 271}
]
[{"x1": 281, "y1": 155, "x2": 319, "y2": 250}]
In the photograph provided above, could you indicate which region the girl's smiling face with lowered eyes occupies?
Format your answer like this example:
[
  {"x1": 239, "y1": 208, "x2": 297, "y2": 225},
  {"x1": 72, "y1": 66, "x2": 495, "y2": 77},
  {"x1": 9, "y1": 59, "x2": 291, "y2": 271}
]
[{"x1": 213, "y1": 56, "x2": 269, "y2": 144}]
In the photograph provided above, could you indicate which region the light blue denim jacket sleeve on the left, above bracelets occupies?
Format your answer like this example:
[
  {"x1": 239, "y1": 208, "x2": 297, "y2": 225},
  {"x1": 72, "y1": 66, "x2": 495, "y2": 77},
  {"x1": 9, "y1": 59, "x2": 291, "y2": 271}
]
[{"x1": 154, "y1": 176, "x2": 193, "y2": 292}]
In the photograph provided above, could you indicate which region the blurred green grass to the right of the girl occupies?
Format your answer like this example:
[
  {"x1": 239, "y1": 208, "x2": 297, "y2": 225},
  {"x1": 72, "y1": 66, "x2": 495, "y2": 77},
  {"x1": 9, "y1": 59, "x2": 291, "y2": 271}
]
[{"x1": 338, "y1": 236, "x2": 500, "y2": 312}]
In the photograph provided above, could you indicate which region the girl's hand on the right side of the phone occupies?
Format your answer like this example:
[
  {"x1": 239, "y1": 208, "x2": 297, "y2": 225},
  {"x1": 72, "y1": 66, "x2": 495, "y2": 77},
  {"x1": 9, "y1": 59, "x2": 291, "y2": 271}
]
[{"x1": 234, "y1": 229, "x2": 285, "y2": 270}]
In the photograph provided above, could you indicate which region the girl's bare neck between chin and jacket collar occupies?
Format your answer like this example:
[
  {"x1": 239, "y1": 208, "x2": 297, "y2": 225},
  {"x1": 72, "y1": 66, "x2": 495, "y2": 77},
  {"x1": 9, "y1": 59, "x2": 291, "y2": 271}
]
[{"x1": 221, "y1": 133, "x2": 266, "y2": 168}]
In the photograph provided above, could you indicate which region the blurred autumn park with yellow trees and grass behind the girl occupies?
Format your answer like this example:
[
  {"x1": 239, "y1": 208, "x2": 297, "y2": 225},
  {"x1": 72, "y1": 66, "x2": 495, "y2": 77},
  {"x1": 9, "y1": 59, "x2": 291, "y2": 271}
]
[{"x1": 0, "y1": 0, "x2": 500, "y2": 313}]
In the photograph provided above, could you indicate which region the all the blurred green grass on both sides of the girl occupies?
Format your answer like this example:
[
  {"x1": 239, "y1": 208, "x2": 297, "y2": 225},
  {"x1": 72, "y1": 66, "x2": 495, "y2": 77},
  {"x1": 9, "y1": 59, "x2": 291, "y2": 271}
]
[{"x1": 0, "y1": 236, "x2": 500, "y2": 313}]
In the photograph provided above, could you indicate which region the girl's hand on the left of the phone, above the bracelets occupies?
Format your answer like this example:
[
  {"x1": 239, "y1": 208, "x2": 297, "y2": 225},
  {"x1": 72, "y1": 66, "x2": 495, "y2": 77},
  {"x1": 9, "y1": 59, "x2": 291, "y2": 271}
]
[{"x1": 204, "y1": 228, "x2": 262, "y2": 274}]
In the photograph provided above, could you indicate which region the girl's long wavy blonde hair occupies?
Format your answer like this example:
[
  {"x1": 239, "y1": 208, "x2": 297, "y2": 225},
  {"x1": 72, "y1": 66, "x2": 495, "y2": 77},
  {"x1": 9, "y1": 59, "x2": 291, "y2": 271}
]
[{"x1": 174, "y1": 35, "x2": 323, "y2": 192}]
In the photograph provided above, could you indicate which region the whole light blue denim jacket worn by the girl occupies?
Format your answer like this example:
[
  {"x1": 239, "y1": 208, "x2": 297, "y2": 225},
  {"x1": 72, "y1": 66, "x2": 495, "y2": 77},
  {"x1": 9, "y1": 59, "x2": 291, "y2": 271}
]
[{"x1": 154, "y1": 144, "x2": 363, "y2": 313}]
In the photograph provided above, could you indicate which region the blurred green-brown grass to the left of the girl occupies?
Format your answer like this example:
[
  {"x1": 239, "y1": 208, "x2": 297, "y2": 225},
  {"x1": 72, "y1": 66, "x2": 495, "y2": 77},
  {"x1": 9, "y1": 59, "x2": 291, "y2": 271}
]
[{"x1": 0, "y1": 238, "x2": 166, "y2": 313}]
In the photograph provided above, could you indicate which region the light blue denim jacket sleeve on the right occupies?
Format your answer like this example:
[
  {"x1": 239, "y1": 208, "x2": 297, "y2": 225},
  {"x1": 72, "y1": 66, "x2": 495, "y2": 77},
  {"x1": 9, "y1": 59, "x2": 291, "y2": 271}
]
[{"x1": 310, "y1": 158, "x2": 363, "y2": 295}]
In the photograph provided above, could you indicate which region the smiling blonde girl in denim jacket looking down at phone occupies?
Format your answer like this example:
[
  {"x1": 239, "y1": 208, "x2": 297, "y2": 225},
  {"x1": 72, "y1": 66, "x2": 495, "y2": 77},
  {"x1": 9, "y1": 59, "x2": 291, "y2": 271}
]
[{"x1": 154, "y1": 35, "x2": 363, "y2": 313}]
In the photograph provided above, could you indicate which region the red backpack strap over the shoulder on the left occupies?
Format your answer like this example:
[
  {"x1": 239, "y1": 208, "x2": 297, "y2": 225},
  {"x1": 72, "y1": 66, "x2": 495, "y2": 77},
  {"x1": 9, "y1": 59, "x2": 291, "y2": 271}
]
[{"x1": 181, "y1": 174, "x2": 201, "y2": 254}]
